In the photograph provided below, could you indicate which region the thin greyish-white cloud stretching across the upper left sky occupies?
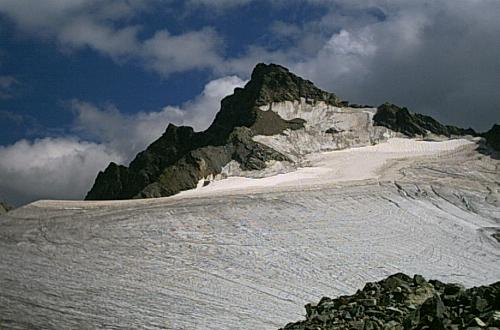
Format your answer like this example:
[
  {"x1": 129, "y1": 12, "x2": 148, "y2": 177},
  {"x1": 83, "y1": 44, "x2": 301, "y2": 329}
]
[{"x1": 0, "y1": 0, "x2": 222, "y2": 75}]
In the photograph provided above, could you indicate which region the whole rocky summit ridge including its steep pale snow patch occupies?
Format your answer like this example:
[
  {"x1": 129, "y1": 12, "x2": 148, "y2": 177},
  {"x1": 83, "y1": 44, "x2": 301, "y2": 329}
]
[{"x1": 86, "y1": 63, "x2": 498, "y2": 200}]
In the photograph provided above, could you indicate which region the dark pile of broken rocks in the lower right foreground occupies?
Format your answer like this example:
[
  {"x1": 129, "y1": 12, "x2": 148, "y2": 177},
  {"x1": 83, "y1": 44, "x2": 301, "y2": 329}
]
[{"x1": 283, "y1": 273, "x2": 500, "y2": 330}]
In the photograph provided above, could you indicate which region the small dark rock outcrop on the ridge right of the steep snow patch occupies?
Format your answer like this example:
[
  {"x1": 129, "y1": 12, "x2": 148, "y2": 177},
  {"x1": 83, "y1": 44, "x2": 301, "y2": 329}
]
[{"x1": 373, "y1": 103, "x2": 477, "y2": 137}]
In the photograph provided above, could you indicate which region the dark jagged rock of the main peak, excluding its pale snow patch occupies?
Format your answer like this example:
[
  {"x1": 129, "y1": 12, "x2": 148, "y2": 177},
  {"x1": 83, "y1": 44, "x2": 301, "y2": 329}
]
[{"x1": 85, "y1": 64, "x2": 332, "y2": 200}]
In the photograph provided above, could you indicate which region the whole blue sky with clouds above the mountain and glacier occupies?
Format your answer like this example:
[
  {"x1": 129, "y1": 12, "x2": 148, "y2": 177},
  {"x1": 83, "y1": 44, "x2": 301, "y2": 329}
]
[{"x1": 0, "y1": 0, "x2": 500, "y2": 205}]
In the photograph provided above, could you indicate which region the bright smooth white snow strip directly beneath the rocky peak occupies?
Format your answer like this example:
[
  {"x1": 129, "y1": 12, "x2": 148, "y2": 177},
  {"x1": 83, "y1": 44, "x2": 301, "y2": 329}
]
[{"x1": 178, "y1": 138, "x2": 475, "y2": 197}]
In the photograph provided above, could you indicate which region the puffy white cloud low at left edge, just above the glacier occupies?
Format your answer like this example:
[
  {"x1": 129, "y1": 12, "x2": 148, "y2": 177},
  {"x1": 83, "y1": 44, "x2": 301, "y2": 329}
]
[{"x1": 0, "y1": 138, "x2": 121, "y2": 204}]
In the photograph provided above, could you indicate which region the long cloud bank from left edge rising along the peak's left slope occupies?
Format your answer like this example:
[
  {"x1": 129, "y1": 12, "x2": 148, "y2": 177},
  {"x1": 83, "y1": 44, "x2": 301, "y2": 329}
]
[{"x1": 0, "y1": 76, "x2": 245, "y2": 205}]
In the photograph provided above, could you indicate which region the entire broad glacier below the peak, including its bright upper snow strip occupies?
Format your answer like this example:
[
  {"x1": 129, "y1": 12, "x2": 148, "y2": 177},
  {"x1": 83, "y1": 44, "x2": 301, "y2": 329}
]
[{"x1": 0, "y1": 139, "x2": 500, "y2": 329}]
